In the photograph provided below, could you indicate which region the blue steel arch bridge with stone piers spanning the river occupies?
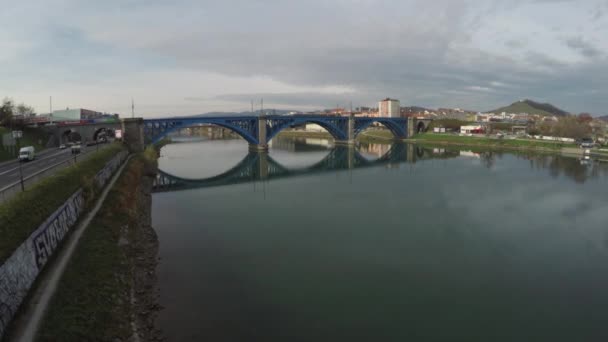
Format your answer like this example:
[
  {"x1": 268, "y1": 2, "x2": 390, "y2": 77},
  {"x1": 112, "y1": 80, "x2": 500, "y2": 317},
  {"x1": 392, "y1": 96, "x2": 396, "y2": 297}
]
[{"x1": 143, "y1": 114, "x2": 429, "y2": 152}]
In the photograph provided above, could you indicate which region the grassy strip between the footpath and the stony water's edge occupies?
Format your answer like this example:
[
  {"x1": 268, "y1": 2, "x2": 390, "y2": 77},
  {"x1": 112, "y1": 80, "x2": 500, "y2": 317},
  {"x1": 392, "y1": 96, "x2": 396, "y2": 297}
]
[{"x1": 37, "y1": 156, "x2": 143, "y2": 341}]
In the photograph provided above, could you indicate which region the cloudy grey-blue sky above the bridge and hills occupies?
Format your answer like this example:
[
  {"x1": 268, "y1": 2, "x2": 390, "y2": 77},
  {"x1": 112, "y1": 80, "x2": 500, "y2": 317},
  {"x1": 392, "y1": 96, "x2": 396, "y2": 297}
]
[{"x1": 0, "y1": 0, "x2": 608, "y2": 117}]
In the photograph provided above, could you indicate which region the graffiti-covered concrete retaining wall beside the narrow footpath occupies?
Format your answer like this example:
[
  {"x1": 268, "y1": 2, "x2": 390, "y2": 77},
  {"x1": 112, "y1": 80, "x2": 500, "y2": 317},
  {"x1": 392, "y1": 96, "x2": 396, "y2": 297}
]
[{"x1": 0, "y1": 151, "x2": 128, "y2": 339}]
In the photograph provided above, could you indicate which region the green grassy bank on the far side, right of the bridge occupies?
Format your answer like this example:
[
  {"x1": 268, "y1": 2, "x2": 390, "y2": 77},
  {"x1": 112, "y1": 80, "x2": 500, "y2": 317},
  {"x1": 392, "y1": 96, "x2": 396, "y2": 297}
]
[{"x1": 407, "y1": 133, "x2": 576, "y2": 151}]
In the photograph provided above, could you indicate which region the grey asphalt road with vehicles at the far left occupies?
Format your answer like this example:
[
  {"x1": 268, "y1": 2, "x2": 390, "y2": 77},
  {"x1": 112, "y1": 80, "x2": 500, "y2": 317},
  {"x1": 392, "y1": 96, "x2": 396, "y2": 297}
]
[{"x1": 0, "y1": 145, "x2": 107, "y2": 189}]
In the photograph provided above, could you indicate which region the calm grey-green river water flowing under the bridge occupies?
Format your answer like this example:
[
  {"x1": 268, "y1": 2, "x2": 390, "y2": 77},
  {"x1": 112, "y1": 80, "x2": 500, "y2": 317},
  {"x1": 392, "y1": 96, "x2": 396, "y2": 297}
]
[{"x1": 153, "y1": 139, "x2": 608, "y2": 342}]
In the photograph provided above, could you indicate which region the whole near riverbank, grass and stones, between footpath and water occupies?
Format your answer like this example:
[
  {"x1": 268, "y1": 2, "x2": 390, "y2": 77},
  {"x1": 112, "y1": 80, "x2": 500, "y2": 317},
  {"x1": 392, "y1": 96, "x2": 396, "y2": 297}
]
[{"x1": 36, "y1": 149, "x2": 161, "y2": 341}]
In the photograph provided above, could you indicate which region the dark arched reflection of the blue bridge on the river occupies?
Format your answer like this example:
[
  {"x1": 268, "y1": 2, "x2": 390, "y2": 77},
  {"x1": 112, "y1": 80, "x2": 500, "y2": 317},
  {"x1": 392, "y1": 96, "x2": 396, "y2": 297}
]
[{"x1": 153, "y1": 144, "x2": 436, "y2": 192}]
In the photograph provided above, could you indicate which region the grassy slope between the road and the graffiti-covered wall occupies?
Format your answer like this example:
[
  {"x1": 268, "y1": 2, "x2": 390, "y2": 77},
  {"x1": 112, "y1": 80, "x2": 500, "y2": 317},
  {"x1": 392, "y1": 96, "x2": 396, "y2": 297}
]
[{"x1": 0, "y1": 144, "x2": 123, "y2": 264}]
